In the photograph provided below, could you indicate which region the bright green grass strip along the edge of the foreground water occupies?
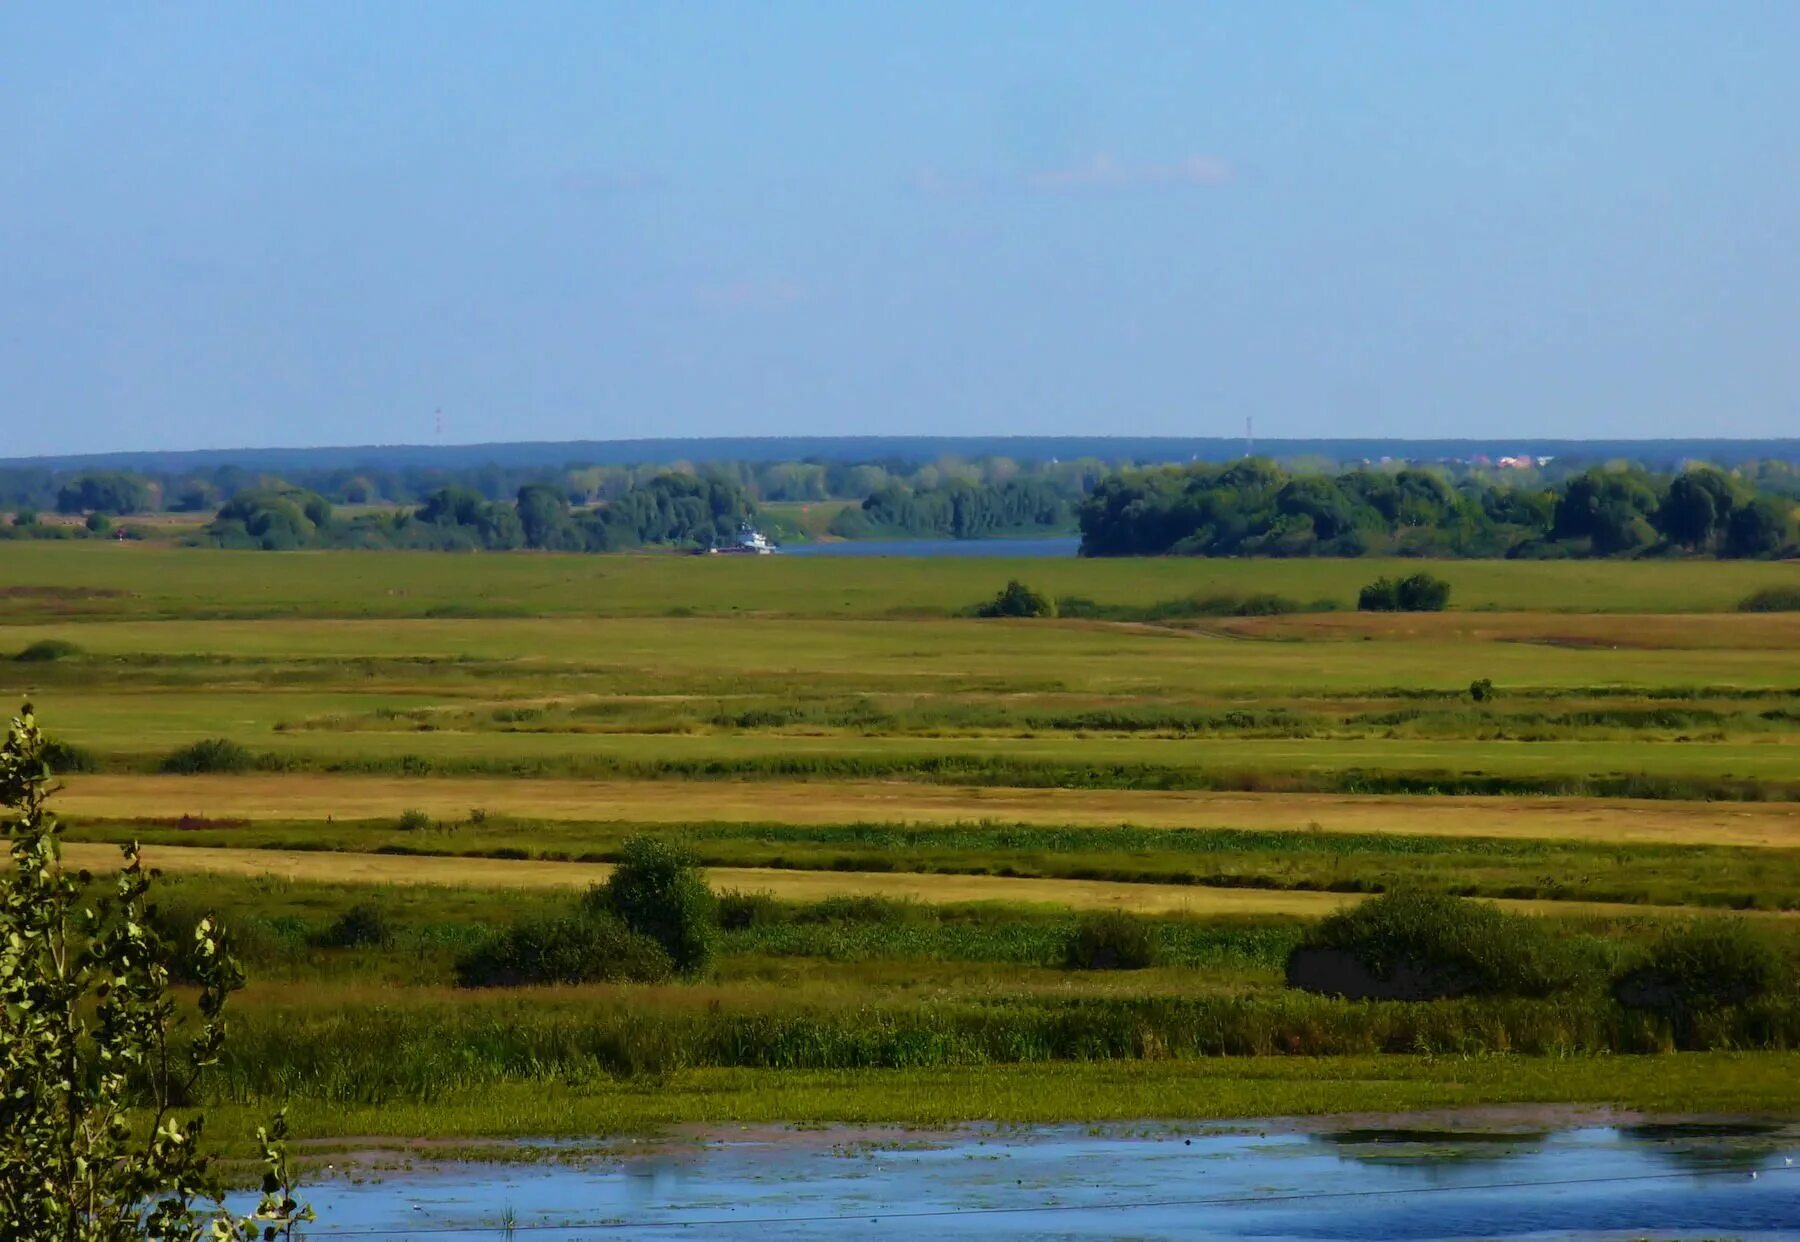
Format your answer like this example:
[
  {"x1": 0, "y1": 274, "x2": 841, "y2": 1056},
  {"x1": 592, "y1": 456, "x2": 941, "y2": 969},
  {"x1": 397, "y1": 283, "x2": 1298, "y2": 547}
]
[{"x1": 189, "y1": 1053, "x2": 1800, "y2": 1166}]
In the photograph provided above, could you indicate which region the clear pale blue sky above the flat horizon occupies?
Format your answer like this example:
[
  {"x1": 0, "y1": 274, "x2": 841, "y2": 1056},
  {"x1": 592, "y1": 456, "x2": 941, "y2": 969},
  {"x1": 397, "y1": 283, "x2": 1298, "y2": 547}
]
[{"x1": 0, "y1": 0, "x2": 1800, "y2": 455}]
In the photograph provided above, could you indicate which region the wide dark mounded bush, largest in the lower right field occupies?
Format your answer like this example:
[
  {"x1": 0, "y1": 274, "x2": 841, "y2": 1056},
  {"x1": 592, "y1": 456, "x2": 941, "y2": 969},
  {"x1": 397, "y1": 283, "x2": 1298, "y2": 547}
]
[{"x1": 1287, "y1": 889, "x2": 1584, "y2": 1001}]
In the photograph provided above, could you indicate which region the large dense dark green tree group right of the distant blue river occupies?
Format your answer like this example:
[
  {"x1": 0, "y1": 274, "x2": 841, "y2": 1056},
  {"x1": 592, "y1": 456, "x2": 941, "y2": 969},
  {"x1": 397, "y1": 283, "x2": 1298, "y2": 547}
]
[{"x1": 1080, "y1": 459, "x2": 1795, "y2": 556}]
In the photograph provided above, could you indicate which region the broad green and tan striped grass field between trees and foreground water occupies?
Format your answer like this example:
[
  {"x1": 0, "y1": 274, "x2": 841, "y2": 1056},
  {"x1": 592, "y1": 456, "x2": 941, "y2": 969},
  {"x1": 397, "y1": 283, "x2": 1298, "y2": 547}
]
[{"x1": 0, "y1": 547, "x2": 1800, "y2": 1138}]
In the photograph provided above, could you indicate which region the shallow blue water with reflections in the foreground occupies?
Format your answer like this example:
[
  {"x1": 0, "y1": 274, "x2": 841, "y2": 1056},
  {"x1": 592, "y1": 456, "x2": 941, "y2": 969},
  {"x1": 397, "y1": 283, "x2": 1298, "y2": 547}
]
[{"x1": 270, "y1": 1125, "x2": 1800, "y2": 1242}]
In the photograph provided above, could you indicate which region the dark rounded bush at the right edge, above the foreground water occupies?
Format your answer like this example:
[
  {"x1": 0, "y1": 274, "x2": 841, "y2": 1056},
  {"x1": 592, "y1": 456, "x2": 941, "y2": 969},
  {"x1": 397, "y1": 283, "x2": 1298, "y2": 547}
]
[{"x1": 1613, "y1": 918, "x2": 1789, "y2": 1026}]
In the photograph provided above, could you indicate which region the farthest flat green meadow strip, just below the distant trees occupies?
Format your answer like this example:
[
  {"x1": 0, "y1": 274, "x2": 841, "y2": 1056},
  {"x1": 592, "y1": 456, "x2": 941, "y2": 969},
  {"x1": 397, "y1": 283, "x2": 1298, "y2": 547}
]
[{"x1": 0, "y1": 542, "x2": 1793, "y2": 621}]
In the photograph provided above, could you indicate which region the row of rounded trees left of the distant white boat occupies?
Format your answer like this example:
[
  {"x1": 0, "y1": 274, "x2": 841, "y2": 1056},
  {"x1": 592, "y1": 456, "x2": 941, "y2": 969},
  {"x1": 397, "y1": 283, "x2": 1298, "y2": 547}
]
[{"x1": 205, "y1": 473, "x2": 754, "y2": 553}]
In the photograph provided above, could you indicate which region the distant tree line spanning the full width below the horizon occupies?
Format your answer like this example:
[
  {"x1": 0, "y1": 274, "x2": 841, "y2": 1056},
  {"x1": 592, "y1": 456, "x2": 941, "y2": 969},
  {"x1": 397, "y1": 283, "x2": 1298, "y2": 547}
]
[{"x1": 14, "y1": 457, "x2": 1800, "y2": 556}]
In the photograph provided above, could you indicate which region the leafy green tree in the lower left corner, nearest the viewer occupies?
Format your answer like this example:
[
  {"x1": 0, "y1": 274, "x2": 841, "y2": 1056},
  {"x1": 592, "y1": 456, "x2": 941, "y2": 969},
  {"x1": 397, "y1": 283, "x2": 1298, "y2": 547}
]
[{"x1": 0, "y1": 704, "x2": 313, "y2": 1242}]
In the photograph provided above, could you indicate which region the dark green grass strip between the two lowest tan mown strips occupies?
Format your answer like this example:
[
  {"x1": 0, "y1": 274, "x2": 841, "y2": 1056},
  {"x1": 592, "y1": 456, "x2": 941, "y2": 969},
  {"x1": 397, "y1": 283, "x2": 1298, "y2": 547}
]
[{"x1": 70, "y1": 814, "x2": 1800, "y2": 909}]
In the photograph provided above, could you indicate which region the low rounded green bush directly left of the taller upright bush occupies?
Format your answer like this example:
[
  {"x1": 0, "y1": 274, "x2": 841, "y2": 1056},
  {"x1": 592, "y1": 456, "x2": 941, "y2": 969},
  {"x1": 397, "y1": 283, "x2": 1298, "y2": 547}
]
[{"x1": 455, "y1": 909, "x2": 675, "y2": 988}]
